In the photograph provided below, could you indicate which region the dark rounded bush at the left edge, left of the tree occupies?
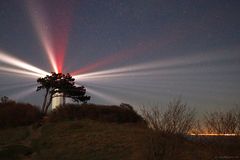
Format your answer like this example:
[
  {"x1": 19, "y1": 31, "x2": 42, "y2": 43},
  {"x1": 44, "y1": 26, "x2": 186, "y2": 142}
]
[{"x1": 0, "y1": 101, "x2": 41, "y2": 128}]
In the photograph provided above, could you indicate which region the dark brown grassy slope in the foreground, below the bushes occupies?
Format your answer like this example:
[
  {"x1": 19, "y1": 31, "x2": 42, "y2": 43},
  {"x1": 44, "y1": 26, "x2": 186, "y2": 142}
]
[{"x1": 0, "y1": 120, "x2": 232, "y2": 160}]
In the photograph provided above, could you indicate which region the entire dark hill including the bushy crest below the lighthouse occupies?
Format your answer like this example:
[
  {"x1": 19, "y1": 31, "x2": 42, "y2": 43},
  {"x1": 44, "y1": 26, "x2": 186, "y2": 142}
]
[{"x1": 0, "y1": 105, "x2": 240, "y2": 160}]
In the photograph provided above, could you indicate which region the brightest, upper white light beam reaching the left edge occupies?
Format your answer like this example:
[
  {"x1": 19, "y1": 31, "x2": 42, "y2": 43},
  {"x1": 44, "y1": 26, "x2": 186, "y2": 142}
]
[{"x1": 0, "y1": 51, "x2": 50, "y2": 76}]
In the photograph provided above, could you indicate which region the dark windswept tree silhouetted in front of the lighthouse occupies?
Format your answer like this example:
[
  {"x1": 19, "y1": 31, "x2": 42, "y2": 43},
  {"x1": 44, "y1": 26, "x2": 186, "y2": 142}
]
[{"x1": 37, "y1": 72, "x2": 90, "y2": 114}]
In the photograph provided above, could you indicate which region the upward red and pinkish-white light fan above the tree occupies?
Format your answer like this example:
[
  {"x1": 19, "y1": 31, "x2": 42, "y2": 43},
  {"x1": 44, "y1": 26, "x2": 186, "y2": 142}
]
[{"x1": 26, "y1": 0, "x2": 74, "y2": 73}]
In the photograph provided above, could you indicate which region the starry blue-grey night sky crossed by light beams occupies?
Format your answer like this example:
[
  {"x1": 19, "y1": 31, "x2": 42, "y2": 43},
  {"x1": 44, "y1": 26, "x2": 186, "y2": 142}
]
[{"x1": 0, "y1": 0, "x2": 240, "y2": 111}]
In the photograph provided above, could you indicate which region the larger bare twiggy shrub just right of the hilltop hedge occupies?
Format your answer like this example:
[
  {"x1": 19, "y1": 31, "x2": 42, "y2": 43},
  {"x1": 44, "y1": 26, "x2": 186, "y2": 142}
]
[{"x1": 141, "y1": 99, "x2": 195, "y2": 134}]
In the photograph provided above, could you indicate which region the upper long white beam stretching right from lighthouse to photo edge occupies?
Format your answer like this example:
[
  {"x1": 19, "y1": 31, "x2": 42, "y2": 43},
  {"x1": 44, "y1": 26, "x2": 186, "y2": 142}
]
[{"x1": 74, "y1": 45, "x2": 239, "y2": 79}]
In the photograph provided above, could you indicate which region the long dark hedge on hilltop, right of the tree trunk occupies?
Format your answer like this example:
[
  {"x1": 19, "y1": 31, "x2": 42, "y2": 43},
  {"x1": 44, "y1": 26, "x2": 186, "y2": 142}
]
[{"x1": 49, "y1": 104, "x2": 143, "y2": 123}]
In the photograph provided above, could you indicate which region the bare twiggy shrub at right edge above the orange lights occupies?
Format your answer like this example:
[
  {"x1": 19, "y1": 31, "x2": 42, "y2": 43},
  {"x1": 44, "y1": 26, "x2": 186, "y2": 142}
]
[{"x1": 204, "y1": 108, "x2": 240, "y2": 134}]
